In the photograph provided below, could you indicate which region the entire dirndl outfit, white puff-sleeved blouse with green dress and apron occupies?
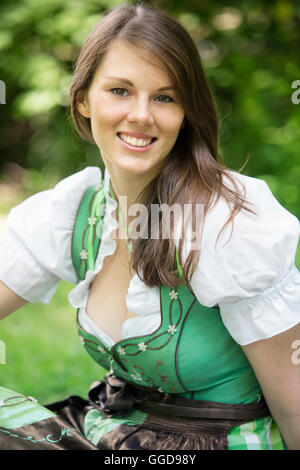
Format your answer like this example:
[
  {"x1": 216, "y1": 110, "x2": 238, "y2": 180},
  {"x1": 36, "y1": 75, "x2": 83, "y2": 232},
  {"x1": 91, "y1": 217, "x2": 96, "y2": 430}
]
[{"x1": 0, "y1": 167, "x2": 300, "y2": 450}]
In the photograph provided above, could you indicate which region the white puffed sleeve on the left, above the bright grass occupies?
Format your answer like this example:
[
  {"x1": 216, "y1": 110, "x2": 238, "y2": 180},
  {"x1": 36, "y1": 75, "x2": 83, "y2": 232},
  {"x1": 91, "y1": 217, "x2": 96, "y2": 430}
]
[{"x1": 0, "y1": 167, "x2": 102, "y2": 304}]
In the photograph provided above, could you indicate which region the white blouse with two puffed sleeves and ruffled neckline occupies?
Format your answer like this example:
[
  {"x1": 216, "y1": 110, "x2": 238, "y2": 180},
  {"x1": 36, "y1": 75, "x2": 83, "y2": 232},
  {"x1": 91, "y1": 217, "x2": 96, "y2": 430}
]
[{"x1": 0, "y1": 167, "x2": 300, "y2": 345}]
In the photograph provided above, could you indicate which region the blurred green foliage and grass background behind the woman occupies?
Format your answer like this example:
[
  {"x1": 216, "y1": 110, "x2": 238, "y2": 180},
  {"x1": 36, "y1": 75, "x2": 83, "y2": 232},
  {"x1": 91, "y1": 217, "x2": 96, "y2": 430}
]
[{"x1": 0, "y1": 0, "x2": 300, "y2": 402}]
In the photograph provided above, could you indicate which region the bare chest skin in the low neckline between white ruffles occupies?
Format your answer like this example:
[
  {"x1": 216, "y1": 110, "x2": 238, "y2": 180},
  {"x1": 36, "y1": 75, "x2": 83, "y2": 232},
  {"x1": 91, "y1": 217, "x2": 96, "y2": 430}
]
[{"x1": 86, "y1": 238, "x2": 136, "y2": 341}]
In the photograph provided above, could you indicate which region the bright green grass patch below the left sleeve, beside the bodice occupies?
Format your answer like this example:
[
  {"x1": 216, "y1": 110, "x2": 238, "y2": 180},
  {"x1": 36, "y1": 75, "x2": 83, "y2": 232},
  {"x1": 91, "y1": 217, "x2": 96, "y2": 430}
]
[{"x1": 0, "y1": 281, "x2": 105, "y2": 403}]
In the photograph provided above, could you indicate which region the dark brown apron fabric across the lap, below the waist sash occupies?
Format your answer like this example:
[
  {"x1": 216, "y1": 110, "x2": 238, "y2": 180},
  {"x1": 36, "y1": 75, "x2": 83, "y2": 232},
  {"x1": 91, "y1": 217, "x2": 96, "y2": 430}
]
[{"x1": 0, "y1": 396, "x2": 264, "y2": 450}]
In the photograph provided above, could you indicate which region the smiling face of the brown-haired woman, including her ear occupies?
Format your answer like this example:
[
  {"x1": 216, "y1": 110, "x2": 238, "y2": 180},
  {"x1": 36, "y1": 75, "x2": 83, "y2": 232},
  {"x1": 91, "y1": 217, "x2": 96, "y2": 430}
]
[{"x1": 77, "y1": 42, "x2": 184, "y2": 177}]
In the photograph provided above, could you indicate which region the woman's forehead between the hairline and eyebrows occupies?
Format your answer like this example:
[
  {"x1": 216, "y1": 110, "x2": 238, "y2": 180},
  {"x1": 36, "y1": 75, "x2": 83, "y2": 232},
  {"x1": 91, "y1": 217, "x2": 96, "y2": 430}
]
[{"x1": 94, "y1": 41, "x2": 172, "y2": 83}]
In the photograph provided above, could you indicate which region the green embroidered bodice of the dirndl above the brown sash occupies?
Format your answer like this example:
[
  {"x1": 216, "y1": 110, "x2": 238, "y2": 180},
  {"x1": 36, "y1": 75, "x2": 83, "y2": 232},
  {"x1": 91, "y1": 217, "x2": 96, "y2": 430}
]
[{"x1": 77, "y1": 285, "x2": 261, "y2": 403}]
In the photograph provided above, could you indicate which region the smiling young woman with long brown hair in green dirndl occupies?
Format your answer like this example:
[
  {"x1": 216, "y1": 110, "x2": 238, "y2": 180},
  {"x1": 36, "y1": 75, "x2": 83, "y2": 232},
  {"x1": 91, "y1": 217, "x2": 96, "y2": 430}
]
[{"x1": 0, "y1": 5, "x2": 300, "y2": 450}]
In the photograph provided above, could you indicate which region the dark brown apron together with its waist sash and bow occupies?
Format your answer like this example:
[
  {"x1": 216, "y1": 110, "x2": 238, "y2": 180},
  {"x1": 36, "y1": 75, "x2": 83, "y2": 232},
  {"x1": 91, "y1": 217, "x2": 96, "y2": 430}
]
[{"x1": 0, "y1": 377, "x2": 269, "y2": 451}]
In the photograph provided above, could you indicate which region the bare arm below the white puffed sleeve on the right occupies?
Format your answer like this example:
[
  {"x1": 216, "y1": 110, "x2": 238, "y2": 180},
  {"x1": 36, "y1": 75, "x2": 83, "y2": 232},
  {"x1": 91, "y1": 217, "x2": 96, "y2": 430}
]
[{"x1": 242, "y1": 323, "x2": 300, "y2": 450}]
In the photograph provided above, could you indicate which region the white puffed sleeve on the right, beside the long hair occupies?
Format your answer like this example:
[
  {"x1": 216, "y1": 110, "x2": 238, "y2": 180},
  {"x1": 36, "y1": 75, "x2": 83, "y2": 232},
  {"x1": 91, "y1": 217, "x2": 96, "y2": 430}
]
[{"x1": 191, "y1": 172, "x2": 300, "y2": 345}]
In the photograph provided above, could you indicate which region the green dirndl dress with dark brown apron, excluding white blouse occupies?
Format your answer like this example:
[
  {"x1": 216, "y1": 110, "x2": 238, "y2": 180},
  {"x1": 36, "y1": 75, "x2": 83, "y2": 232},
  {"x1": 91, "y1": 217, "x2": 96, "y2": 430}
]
[{"x1": 0, "y1": 285, "x2": 286, "y2": 450}]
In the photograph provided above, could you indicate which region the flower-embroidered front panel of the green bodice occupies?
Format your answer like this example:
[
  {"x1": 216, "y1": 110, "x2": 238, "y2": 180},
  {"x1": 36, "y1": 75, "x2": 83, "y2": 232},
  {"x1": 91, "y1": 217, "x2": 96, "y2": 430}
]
[{"x1": 77, "y1": 286, "x2": 196, "y2": 393}]
